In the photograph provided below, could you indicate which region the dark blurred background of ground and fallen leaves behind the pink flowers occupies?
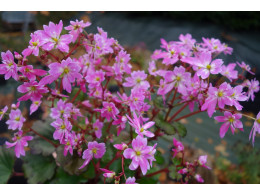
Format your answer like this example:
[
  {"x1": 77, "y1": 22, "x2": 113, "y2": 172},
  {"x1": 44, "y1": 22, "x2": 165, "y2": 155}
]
[{"x1": 0, "y1": 12, "x2": 260, "y2": 183}]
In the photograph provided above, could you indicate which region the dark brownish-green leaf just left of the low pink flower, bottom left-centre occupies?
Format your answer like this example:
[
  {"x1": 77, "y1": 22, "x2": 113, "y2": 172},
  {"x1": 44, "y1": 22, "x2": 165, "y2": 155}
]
[{"x1": 56, "y1": 146, "x2": 85, "y2": 175}]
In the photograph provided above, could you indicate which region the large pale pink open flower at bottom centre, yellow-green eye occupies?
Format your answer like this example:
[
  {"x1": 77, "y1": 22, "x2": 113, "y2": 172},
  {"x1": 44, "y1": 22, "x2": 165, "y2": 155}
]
[{"x1": 123, "y1": 135, "x2": 154, "y2": 175}]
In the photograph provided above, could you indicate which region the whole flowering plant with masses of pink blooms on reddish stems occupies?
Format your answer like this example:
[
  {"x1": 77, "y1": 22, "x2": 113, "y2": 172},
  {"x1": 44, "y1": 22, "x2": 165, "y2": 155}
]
[{"x1": 0, "y1": 20, "x2": 260, "y2": 184}]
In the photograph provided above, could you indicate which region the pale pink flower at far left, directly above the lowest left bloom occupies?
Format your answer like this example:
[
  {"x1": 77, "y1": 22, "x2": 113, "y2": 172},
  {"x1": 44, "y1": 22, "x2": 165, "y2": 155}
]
[{"x1": 6, "y1": 109, "x2": 25, "y2": 130}]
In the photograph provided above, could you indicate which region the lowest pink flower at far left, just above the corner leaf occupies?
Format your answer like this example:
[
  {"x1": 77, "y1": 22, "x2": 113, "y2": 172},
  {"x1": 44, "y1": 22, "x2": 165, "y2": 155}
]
[{"x1": 5, "y1": 131, "x2": 33, "y2": 158}]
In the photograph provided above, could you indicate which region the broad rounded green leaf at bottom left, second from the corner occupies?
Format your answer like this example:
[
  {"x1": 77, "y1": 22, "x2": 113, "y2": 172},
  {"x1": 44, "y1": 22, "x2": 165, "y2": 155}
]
[{"x1": 23, "y1": 155, "x2": 56, "y2": 184}]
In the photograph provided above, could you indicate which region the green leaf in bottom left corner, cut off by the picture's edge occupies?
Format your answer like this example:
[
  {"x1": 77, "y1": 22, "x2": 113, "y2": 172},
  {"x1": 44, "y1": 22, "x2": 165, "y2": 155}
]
[{"x1": 0, "y1": 146, "x2": 15, "y2": 184}]
